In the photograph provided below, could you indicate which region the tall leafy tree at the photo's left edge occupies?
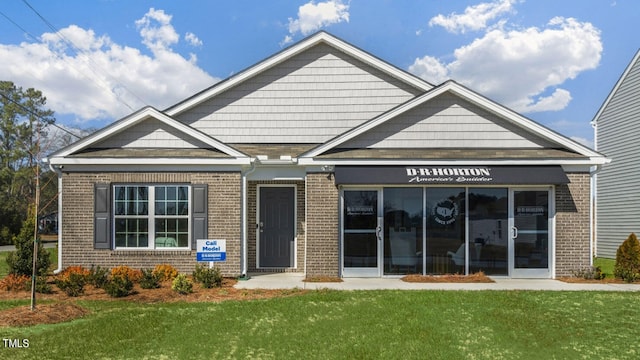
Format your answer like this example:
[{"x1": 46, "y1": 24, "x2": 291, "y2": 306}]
[{"x1": 0, "y1": 81, "x2": 55, "y2": 244}]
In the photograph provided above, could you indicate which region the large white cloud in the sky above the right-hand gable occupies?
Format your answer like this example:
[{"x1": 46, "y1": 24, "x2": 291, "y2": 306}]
[{"x1": 409, "y1": 11, "x2": 602, "y2": 113}]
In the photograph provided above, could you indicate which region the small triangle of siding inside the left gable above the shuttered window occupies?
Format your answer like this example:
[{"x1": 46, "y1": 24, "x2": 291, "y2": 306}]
[{"x1": 95, "y1": 119, "x2": 211, "y2": 149}]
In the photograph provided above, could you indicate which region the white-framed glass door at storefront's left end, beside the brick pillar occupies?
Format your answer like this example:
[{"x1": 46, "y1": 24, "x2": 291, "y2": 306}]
[{"x1": 342, "y1": 190, "x2": 382, "y2": 276}]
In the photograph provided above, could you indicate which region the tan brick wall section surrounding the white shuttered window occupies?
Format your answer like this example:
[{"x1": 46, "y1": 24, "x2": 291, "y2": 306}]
[{"x1": 61, "y1": 172, "x2": 241, "y2": 276}]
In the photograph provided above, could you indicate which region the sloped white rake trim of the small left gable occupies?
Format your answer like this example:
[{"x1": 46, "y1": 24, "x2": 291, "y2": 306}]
[{"x1": 49, "y1": 106, "x2": 249, "y2": 164}]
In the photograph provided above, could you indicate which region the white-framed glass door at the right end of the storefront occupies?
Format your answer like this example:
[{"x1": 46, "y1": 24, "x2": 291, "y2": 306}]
[{"x1": 511, "y1": 189, "x2": 553, "y2": 278}]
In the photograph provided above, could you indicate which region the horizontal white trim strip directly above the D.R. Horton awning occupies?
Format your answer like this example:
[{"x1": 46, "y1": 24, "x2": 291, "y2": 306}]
[{"x1": 298, "y1": 158, "x2": 601, "y2": 166}]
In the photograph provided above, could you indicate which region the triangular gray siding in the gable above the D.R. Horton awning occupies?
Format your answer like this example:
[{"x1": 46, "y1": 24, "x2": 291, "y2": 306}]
[{"x1": 341, "y1": 94, "x2": 553, "y2": 149}]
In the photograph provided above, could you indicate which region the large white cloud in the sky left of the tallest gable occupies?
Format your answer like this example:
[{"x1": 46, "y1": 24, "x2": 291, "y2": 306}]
[{"x1": 0, "y1": 9, "x2": 217, "y2": 122}]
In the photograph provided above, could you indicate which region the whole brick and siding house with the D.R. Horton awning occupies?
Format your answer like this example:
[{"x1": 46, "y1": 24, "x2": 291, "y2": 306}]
[{"x1": 48, "y1": 32, "x2": 607, "y2": 278}]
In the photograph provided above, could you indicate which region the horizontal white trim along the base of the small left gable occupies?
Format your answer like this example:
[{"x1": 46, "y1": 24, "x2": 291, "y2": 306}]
[{"x1": 48, "y1": 157, "x2": 251, "y2": 166}]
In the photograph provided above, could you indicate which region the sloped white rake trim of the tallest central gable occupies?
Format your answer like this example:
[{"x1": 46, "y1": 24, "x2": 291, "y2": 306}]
[{"x1": 164, "y1": 32, "x2": 433, "y2": 116}]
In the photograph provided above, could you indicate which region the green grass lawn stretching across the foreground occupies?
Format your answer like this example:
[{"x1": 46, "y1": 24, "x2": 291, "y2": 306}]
[{"x1": 0, "y1": 290, "x2": 640, "y2": 359}]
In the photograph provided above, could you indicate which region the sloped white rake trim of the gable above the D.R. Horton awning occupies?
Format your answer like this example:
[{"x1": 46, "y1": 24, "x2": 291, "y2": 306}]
[{"x1": 300, "y1": 80, "x2": 607, "y2": 164}]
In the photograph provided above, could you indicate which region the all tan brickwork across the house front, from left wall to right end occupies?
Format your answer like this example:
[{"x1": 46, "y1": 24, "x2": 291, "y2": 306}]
[{"x1": 61, "y1": 172, "x2": 591, "y2": 276}]
